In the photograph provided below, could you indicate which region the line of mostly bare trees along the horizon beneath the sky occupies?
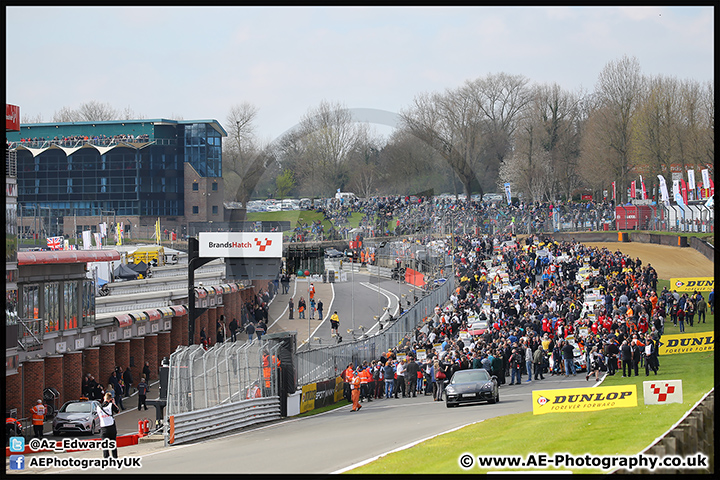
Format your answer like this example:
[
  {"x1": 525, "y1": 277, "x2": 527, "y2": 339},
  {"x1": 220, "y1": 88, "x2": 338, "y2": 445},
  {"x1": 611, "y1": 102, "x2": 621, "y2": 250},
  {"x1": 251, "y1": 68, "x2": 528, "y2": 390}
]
[{"x1": 31, "y1": 56, "x2": 715, "y2": 204}]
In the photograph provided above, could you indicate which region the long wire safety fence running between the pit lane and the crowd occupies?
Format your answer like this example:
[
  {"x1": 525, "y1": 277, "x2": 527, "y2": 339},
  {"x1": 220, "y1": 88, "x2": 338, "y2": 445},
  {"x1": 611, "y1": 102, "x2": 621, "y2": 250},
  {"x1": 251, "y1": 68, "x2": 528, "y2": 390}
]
[{"x1": 296, "y1": 281, "x2": 453, "y2": 385}]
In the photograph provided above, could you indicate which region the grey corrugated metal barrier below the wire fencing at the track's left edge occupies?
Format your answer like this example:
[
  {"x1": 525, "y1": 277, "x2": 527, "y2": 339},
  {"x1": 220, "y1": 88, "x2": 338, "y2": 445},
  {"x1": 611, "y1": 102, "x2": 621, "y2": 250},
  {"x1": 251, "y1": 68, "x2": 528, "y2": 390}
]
[{"x1": 165, "y1": 396, "x2": 280, "y2": 446}]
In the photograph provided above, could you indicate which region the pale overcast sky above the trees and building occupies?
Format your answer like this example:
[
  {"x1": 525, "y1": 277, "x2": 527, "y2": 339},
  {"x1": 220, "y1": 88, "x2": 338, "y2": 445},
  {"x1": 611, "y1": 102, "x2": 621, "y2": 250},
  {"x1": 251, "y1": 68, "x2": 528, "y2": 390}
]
[{"x1": 6, "y1": 7, "x2": 715, "y2": 141}]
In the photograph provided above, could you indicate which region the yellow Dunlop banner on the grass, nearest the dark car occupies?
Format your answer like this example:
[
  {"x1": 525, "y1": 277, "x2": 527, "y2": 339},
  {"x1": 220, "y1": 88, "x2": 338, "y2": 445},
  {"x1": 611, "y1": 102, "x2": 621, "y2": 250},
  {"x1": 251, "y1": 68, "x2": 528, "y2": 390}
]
[{"x1": 533, "y1": 385, "x2": 638, "y2": 415}]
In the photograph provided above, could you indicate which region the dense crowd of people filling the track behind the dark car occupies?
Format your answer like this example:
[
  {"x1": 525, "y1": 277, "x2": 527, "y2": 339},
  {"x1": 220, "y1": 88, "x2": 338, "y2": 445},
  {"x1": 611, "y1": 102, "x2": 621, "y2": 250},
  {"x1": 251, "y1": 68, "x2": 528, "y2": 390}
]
[{"x1": 342, "y1": 228, "x2": 714, "y2": 404}]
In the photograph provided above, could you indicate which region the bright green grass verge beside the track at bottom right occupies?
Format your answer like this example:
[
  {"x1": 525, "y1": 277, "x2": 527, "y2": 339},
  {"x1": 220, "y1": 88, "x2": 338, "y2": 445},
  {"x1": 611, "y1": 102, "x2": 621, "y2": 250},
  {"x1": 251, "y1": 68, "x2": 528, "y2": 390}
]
[{"x1": 348, "y1": 298, "x2": 715, "y2": 474}]
